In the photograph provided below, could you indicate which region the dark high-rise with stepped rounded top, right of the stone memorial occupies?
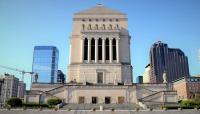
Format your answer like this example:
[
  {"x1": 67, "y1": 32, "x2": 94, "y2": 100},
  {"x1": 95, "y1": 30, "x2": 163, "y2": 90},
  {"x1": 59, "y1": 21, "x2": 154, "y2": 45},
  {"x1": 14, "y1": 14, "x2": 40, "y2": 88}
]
[{"x1": 150, "y1": 41, "x2": 189, "y2": 83}]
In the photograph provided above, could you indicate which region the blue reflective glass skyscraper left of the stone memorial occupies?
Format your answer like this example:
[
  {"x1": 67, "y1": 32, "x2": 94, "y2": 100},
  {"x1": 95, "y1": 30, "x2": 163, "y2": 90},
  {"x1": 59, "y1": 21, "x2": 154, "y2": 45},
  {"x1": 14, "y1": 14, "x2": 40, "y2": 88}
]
[{"x1": 32, "y1": 46, "x2": 59, "y2": 83}]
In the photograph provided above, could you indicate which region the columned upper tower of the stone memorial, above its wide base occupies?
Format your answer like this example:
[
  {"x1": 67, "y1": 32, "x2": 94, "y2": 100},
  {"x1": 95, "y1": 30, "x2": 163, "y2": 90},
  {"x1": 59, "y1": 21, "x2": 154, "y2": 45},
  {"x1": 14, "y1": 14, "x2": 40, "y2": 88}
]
[{"x1": 68, "y1": 4, "x2": 132, "y2": 84}]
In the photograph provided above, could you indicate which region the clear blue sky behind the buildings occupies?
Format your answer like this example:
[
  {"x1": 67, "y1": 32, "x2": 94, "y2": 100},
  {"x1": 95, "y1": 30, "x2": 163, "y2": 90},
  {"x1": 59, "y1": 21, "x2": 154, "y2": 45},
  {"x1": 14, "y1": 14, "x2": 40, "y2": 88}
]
[{"x1": 0, "y1": 0, "x2": 200, "y2": 88}]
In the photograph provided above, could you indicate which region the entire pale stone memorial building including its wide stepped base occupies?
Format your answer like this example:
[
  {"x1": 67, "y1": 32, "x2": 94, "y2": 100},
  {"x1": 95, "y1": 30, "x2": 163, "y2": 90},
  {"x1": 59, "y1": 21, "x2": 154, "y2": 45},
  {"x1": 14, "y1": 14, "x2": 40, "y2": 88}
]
[{"x1": 25, "y1": 5, "x2": 177, "y2": 108}]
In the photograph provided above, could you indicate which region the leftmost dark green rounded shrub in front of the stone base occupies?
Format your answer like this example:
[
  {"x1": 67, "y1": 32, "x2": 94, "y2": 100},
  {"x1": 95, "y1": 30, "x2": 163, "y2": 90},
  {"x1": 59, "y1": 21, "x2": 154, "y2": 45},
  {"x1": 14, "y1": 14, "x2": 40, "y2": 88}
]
[{"x1": 6, "y1": 98, "x2": 22, "y2": 107}]
